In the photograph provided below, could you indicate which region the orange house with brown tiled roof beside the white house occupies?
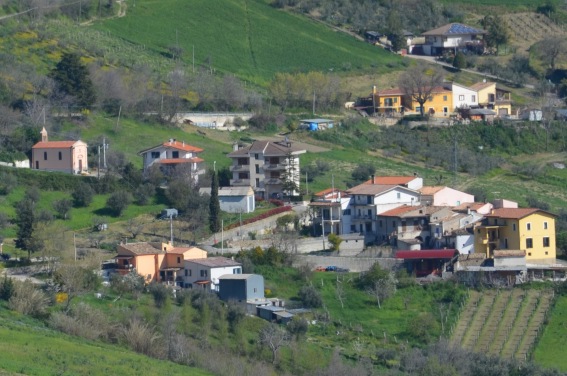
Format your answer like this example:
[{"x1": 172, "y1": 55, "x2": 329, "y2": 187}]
[{"x1": 115, "y1": 242, "x2": 207, "y2": 284}]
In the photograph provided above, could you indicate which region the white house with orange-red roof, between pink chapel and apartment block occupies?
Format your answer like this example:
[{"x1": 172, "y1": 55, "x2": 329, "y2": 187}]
[{"x1": 138, "y1": 138, "x2": 205, "y2": 182}]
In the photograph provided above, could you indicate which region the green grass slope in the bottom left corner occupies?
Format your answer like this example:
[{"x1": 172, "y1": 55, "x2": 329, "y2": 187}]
[{"x1": 0, "y1": 307, "x2": 209, "y2": 376}]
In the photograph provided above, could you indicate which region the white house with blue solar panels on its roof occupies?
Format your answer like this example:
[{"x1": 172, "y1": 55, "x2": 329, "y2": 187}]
[{"x1": 422, "y1": 23, "x2": 486, "y2": 55}]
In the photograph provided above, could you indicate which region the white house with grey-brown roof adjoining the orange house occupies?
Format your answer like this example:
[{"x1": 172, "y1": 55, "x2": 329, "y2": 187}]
[{"x1": 183, "y1": 257, "x2": 242, "y2": 291}]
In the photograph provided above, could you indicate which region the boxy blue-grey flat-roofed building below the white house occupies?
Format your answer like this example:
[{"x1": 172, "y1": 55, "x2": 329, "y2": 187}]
[{"x1": 219, "y1": 274, "x2": 264, "y2": 302}]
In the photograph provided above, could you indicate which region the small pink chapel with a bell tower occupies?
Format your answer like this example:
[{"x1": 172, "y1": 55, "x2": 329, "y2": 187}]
[{"x1": 32, "y1": 128, "x2": 89, "y2": 174}]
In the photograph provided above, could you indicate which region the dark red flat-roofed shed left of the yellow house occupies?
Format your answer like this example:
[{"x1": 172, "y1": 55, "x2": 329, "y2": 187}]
[{"x1": 396, "y1": 249, "x2": 459, "y2": 277}]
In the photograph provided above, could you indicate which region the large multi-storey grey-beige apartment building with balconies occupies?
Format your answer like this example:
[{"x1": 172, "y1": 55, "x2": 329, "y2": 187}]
[{"x1": 228, "y1": 140, "x2": 306, "y2": 199}]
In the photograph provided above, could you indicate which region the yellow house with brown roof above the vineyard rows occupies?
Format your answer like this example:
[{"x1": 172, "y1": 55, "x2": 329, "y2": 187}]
[{"x1": 474, "y1": 208, "x2": 556, "y2": 262}]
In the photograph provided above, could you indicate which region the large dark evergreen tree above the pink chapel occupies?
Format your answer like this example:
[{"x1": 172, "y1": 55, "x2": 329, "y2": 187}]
[{"x1": 50, "y1": 53, "x2": 96, "y2": 108}]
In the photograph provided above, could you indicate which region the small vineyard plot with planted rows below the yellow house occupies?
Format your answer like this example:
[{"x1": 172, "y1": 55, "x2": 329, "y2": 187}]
[{"x1": 451, "y1": 289, "x2": 553, "y2": 360}]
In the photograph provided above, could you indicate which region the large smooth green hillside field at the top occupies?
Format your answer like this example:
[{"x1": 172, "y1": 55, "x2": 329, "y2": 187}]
[{"x1": 95, "y1": 0, "x2": 399, "y2": 83}]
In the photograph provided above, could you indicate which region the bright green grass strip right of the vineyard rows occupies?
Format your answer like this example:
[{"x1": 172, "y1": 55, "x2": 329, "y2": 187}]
[{"x1": 533, "y1": 296, "x2": 567, "y2": 372}]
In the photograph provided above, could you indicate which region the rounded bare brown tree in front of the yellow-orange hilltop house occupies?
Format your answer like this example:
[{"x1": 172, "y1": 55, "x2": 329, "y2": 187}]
[{"x1": 398, "y1": 65, "x2": 443, "y2": 116}]
